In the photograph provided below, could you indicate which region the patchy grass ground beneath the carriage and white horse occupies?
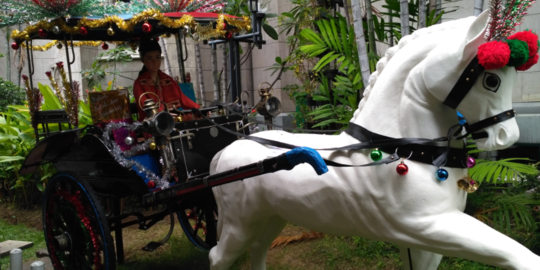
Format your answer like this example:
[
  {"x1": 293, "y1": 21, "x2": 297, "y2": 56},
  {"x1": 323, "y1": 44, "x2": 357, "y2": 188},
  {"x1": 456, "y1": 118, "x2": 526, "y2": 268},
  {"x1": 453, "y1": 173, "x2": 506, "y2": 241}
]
[{"x1": 0, "y1": 203, "x2": 502, "y2": 270}]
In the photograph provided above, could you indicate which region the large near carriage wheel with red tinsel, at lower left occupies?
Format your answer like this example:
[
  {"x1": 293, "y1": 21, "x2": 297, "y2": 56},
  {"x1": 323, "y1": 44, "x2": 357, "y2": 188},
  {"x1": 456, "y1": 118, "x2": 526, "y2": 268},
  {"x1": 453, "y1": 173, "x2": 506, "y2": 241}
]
[{"x1": 43, "y1": 173, "x2": 116, "y2": 270}]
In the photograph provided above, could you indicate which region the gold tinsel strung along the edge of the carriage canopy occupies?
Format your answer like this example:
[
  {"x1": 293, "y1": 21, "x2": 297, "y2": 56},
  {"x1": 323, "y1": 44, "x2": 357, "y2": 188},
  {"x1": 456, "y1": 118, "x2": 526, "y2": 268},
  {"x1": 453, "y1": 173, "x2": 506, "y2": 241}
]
[{"x1": 11, "y1": 9, "x2": 251, "y2": 45}]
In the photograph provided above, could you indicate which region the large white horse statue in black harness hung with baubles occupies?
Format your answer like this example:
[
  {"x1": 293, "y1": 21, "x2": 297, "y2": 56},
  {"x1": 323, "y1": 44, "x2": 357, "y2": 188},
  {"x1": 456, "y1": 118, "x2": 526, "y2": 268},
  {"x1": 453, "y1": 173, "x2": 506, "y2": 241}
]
[{"x1": 209, "y1": 9, "x2": 540, "y2": 270}]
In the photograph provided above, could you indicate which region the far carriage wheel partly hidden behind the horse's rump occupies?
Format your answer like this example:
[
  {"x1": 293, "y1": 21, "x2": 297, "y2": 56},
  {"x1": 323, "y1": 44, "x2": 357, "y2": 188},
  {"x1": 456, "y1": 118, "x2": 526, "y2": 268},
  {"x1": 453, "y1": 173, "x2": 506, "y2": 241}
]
[{"x1": 177, "y1": 191, "x2": 218, "y2": 251}]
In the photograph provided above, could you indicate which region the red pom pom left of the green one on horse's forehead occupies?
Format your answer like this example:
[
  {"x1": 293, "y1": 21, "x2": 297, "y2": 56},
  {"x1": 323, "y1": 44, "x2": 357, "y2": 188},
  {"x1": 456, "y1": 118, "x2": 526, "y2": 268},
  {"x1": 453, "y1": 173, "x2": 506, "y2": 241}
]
[{"x1": 478, "y1": 41, "x2": 511, "y2": 69}]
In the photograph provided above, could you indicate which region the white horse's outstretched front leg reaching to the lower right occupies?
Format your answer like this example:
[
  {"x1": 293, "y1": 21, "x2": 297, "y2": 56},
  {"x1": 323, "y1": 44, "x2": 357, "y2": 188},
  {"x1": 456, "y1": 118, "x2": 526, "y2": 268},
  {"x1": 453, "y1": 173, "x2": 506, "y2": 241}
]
[{"x1": 407, "y1": 210, "x2": 540, "y2": 270}]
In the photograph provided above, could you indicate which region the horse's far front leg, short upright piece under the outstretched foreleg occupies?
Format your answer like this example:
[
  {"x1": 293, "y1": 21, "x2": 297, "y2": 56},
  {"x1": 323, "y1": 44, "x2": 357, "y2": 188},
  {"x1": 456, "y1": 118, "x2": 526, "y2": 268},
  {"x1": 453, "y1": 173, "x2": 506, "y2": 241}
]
[{"x1": 399, "y1": 247, "x2": 442, "y2": 270}]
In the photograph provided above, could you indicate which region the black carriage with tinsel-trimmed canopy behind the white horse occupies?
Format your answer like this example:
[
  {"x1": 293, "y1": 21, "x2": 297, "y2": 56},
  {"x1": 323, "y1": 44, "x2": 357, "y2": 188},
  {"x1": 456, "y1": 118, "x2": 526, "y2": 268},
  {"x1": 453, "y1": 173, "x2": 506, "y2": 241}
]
[{"x1": 13, "y1": 5, "x2": 324, "y2": 269}]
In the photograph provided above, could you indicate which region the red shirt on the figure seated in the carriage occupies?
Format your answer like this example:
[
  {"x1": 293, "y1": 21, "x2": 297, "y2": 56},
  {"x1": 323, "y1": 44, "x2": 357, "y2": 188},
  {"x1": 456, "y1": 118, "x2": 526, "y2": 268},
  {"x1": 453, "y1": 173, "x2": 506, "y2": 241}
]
[{"x1": 133, "y1": 70, "x2": 200, "y2": 121}]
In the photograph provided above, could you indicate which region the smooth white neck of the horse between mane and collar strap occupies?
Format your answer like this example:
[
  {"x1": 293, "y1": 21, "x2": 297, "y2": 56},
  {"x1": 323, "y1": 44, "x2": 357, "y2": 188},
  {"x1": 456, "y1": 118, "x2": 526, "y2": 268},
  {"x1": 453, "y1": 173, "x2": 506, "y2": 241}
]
[{"x1": 352, "y1": 43, "x2": 457, "y2": 139}]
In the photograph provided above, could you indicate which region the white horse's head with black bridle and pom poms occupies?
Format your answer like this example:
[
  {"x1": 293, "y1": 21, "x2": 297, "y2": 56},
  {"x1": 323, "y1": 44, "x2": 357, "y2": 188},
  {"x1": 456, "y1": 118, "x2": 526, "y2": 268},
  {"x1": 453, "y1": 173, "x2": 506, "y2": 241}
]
[{"x1": 424, "y1": 12, "x2": 538, "y2": 150}]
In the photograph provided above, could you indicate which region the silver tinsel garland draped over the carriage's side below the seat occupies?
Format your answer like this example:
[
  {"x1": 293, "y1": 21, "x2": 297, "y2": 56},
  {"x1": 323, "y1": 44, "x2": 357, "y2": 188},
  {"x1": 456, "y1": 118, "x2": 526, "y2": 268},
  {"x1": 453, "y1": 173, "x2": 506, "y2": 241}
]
[{"x1": 103, "y1": 122, "x2": 171, "y2": 189}]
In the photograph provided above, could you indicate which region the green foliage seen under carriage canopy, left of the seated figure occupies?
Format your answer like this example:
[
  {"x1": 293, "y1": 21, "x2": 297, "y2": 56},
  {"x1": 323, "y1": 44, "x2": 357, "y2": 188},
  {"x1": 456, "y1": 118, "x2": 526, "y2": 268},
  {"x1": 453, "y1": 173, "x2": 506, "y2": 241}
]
[{"x1": 81, "y1": 45, "x2": 135, "y2": 91}]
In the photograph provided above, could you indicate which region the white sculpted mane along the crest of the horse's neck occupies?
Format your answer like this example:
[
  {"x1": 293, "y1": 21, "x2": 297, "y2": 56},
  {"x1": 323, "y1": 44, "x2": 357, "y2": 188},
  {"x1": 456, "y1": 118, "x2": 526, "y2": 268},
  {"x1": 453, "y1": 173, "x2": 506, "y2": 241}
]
[{"x1": 350, "y1": 18, "x2": 478, "y2": 122}]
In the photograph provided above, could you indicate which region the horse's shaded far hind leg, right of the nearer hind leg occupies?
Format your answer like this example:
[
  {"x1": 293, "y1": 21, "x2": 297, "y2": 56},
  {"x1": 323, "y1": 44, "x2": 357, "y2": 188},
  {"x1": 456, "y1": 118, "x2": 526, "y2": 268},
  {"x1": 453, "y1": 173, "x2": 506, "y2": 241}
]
[{"x1": 251, "y1": 216, "x2": 287, "y2": 270}]
